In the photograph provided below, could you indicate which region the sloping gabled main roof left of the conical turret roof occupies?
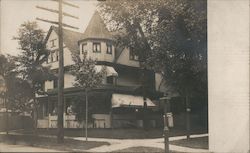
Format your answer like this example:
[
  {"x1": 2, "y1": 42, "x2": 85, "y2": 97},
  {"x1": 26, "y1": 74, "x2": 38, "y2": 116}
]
[{"x1": 45, "y1": 26, "x2": 84, "y2": 52}]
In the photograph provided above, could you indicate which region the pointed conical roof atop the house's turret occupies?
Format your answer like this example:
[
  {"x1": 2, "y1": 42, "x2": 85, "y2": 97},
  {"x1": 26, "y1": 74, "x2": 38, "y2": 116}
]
[{"x1": 84, "y1": 11, "x2": 113, "y2": 39}]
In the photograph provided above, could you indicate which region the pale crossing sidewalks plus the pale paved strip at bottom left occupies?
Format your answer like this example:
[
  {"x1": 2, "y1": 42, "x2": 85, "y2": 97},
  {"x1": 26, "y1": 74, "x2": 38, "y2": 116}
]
[{"x1": 0, "y1": 130, "x2": 209, "y2": 153}]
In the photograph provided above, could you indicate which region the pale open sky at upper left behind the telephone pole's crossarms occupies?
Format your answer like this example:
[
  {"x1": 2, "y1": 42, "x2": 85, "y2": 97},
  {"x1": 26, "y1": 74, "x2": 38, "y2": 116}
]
[{"x1": 0, "y1": 0, "x2": 98, "y2": 55}]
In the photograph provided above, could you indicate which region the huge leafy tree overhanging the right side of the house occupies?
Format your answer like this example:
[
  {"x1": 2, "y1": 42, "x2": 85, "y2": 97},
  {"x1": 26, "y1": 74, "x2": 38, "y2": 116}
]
[{"x1": 99, "y1": 0, "x2": 207, "y2": 137}]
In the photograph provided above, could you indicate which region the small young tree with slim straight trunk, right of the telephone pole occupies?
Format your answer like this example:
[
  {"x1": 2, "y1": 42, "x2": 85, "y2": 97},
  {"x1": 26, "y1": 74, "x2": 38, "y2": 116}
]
[{"x1": 71, "y1": 52, "x2": 104, "y2": 141}]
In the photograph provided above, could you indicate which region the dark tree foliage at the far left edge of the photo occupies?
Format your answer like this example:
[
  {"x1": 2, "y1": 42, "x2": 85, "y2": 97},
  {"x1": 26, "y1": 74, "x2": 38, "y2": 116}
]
[{"x1": 0, "y1": 55, "x2": 32, "y2": 112}]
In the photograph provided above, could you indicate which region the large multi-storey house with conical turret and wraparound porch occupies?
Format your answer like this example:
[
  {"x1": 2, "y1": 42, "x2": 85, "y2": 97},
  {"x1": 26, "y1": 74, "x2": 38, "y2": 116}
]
[{"x1": 38, "y1": 12, "x2": 162, "y2": 128}]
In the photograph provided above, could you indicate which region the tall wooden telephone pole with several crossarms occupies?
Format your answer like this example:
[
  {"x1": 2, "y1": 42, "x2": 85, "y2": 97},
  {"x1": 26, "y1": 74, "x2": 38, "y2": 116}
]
[{"x1": 37, "y1": 0, "x2": 79, "y2": 143}]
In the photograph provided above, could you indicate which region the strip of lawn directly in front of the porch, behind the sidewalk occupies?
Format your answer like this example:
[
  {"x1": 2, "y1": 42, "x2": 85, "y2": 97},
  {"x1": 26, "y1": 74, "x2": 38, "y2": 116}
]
[{"x1": 17, "y1": 128, "x2": 206, "y2": 139}]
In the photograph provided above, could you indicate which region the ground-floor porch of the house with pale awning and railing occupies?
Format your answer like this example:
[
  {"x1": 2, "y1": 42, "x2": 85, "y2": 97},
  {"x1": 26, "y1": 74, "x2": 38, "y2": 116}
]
[{"x1": 37, "y1": 91, "x2": 162, "y2": 129}]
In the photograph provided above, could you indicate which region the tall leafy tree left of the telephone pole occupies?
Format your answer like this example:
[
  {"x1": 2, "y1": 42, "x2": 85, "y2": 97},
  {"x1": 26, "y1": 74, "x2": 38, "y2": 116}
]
[{"x1": 14, "y1": 21, "x2": 53, "y2": 131}]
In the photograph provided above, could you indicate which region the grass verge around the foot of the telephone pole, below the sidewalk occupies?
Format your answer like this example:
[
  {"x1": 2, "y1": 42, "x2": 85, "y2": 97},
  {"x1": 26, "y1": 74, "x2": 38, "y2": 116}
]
[{"x1": 0, "y1": 135, "x2": 110, "y2": 152}]
